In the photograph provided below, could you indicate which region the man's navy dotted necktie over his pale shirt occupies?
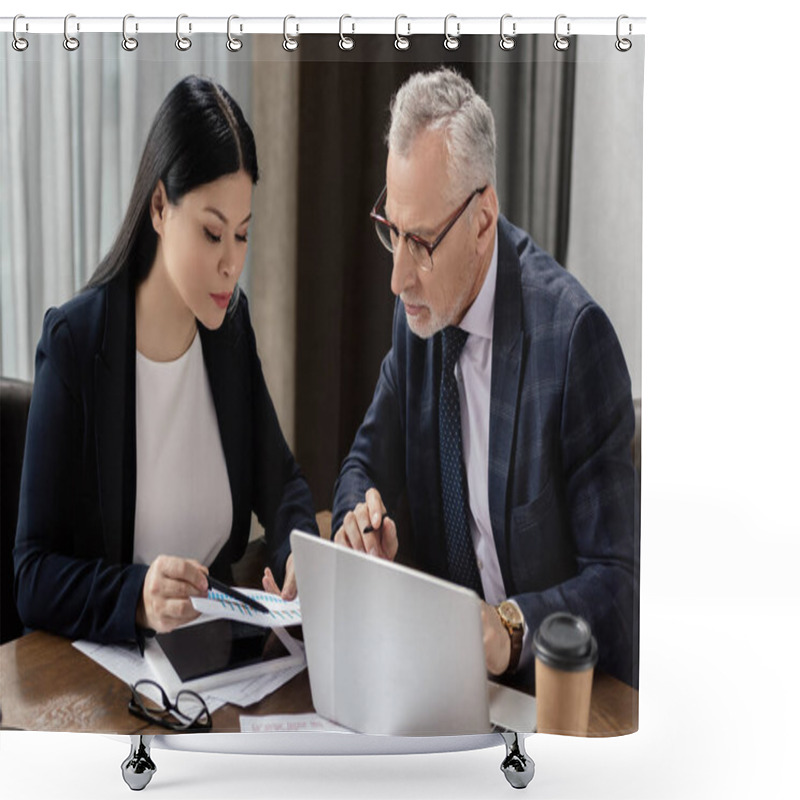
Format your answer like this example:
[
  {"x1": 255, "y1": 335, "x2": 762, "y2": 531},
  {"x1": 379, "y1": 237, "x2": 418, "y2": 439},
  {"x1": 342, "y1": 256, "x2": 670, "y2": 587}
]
[{"x1": 439, "y1": 326, "x2": 483, "y2": 597}]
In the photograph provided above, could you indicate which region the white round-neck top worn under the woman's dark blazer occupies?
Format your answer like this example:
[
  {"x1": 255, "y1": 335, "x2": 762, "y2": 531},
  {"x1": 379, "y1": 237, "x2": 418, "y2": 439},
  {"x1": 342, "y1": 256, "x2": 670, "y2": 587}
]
[{"x1": 133, "y1": 334, "x2": 233, "y2": 566}]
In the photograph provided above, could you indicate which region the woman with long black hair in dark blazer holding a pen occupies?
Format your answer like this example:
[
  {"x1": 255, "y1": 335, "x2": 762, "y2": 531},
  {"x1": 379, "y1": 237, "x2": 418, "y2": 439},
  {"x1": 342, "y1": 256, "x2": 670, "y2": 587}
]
[{"x1": 14, "y1": 76, "x2": 317, "y2": 642}]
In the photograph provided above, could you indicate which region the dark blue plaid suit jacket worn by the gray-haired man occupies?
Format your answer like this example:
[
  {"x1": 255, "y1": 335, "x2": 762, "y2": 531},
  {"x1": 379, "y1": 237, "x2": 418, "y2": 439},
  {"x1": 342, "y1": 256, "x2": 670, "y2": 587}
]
[{"x1": 332, "y1": 217, "x2": 638, "y2": 687}]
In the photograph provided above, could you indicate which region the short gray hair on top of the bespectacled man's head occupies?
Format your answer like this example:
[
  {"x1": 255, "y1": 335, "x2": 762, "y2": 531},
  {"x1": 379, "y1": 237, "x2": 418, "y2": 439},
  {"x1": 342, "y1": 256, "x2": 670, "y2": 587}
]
[{"x1": 386, "y1": 67, "x2": 497, "y2": 203}]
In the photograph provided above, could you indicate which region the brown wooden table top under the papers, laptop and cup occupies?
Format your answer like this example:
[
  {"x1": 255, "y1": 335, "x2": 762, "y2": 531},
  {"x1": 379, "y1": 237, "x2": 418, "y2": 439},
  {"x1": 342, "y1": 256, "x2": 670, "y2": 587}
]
[{"x1": 0, "y1": 631, "x2": 639, "y2": 736}]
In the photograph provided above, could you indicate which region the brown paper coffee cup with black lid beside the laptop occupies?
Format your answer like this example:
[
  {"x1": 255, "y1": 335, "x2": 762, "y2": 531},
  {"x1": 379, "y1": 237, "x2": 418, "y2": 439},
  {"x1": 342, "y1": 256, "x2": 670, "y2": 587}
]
[{"x1": 533, "y1": 611, "x2": 597, "y2": 736}]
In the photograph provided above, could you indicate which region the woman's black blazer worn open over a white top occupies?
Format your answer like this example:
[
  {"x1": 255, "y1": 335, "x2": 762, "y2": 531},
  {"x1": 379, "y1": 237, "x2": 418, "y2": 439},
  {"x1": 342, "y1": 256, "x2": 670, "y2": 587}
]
[{"x1": 14, "y1": 273, "x2": 317, "y2": 642}]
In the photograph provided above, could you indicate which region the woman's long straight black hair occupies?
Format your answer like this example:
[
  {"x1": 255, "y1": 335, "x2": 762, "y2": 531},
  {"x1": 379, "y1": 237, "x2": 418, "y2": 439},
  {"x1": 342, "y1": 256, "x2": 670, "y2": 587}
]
[{"x1": 86, "y1": 75, "x2": 258, "y2": 289}]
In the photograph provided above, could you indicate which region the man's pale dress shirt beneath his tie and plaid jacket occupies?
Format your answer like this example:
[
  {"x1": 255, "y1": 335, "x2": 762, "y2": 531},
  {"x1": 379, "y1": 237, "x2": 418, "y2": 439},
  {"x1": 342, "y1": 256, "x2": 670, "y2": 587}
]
[{"x1": 455, "y1": 233, "x2": 531, "y2": 666}]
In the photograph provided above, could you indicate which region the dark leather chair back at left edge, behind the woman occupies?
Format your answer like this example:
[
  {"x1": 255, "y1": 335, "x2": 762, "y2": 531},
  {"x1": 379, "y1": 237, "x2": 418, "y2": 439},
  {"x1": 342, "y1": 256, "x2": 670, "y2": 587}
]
[{"x1": 0, "y1": 378, "x2": 33, "y2": 644}]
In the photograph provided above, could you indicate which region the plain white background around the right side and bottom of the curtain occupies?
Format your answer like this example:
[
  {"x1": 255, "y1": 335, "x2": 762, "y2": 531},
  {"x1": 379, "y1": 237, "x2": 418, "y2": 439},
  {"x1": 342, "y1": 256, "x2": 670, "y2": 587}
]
[{"x1": 0, "y1": 0, "x2": 800, "y2": 800}]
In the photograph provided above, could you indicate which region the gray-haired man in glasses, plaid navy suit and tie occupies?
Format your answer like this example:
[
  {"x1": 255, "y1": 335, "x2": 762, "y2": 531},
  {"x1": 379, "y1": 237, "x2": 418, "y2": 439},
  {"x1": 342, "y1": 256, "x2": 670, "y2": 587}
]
[{"x1": 333, "y1": 69, "x2": 637, "y2": 689}]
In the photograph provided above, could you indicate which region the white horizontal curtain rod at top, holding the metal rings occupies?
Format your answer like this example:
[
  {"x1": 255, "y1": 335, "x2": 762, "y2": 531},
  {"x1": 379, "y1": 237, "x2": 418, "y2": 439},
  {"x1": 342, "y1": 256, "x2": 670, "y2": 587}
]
[{"x1": 0, "y1": 14, "x2": 646, "y2": 38}]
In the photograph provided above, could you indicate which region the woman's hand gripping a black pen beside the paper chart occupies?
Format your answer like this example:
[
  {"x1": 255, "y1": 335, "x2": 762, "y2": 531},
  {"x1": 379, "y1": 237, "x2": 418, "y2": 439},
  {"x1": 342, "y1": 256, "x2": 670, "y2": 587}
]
[{"x1": 136, "y1": 555, "x2": 208, "y2": 633}]
